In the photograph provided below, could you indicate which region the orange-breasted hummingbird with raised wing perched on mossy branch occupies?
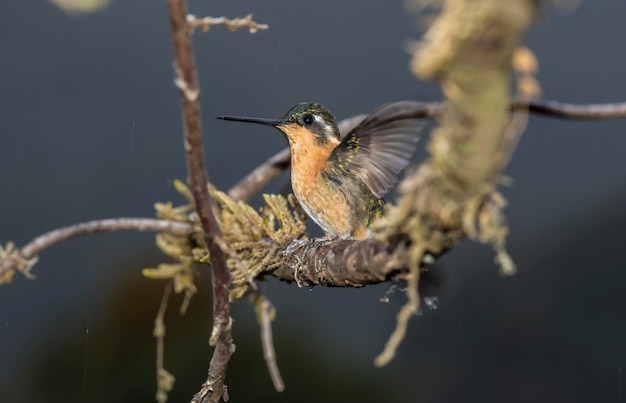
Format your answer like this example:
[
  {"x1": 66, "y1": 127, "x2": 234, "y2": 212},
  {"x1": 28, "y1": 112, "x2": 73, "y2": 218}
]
[{"x1": 217, "y1": 101, "x2": 425, "y2": 240}]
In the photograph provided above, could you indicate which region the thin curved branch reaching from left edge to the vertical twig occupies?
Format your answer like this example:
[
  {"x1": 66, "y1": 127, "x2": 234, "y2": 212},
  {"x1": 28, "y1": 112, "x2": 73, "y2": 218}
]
[{"x1": 0, "y1": 218, "x2": 193, "y2": 279}]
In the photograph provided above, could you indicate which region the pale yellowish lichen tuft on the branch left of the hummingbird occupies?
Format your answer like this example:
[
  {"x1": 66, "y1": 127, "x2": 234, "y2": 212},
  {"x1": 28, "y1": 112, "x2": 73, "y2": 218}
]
[{"x1": 143, "y1": 181, "x2": 306, "y2": 299}]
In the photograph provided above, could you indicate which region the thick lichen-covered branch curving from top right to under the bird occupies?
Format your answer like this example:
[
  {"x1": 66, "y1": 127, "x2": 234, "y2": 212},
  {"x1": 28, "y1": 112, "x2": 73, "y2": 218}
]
[{"x1": 229, "y1": 0, "x2": 536, "y2": 365}]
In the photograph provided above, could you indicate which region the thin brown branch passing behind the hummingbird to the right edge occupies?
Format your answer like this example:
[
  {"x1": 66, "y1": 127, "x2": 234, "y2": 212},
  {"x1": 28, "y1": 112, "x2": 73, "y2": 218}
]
[{"x1": 228, "y1": 100, "x2": 626, "y2": 201}]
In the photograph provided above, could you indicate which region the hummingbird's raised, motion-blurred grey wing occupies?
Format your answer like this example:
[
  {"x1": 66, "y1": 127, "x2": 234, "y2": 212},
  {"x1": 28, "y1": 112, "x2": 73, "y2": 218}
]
[{"x1": 328, "y1": 101, "x2": 426, "y2": 198}]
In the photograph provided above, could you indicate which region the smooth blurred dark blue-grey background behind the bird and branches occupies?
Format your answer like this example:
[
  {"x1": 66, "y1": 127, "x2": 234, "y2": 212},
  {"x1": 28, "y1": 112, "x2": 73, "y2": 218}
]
[{"x1": 0, "y1": 0, "x2": 626, "y2": 402}]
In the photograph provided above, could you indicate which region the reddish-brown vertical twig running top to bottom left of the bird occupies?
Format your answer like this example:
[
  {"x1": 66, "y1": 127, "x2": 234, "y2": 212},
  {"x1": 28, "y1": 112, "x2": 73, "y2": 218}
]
[{"x1": 167, "y1": 0, "x2": 235, "y2": 402}]
